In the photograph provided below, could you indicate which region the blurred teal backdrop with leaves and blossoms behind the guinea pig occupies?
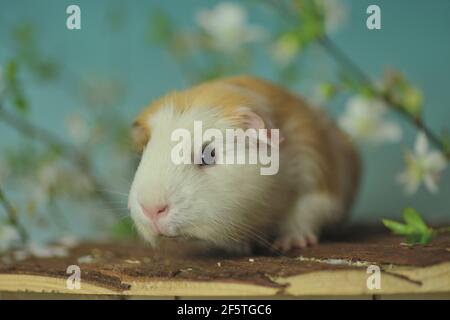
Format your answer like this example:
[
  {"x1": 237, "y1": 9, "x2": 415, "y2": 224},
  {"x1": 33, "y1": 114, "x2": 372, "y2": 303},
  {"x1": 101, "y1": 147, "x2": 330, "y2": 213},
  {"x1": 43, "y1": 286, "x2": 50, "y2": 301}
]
[{"x1": 0, "y1": 0, "x2": 450, "y2": 250}]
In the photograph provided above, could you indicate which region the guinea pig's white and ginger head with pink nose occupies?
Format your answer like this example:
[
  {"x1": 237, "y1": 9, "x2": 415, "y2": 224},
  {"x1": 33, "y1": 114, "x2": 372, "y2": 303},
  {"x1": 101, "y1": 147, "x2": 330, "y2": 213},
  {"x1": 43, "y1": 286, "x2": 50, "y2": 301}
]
[{"x1": 129, "y1": 82, "x2": 282, "y2": 245}]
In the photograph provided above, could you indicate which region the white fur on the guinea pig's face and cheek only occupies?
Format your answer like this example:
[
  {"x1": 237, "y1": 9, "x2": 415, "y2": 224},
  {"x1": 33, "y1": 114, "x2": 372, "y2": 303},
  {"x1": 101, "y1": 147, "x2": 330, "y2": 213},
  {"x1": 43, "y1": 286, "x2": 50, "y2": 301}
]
[{"x1": 129, "y1": 105, "x2": 282, "y2": 248}]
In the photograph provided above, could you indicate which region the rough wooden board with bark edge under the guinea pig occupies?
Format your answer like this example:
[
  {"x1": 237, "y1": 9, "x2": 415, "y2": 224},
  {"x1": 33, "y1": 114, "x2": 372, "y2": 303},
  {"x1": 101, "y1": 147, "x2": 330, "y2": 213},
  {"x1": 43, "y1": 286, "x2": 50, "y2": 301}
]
[{"x1": 0, "y1": 227, "x2": 450, "y2": 297}]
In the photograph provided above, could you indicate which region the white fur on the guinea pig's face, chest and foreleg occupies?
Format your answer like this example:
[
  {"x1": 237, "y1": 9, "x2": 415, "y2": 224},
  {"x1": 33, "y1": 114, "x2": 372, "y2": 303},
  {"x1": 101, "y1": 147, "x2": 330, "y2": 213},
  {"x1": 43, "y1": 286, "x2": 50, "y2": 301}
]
[{"x1": 129, "y1": 89, "x2": 358, "y2": 252}]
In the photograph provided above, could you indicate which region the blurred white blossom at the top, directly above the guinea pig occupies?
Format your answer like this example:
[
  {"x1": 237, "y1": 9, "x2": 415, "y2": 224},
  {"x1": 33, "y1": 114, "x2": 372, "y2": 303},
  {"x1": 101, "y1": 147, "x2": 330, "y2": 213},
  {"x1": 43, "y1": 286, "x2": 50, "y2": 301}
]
[{"x1": 196, "y1": 2, "x2": 264, "y2": 52}]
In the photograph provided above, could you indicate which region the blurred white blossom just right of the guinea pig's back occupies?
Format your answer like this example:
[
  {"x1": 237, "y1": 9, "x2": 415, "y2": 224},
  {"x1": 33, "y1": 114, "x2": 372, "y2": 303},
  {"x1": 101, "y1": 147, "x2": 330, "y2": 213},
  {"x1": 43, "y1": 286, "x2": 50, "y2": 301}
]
[{"x1": 339, "y1": 96, "x2": 402, "y2": 143}]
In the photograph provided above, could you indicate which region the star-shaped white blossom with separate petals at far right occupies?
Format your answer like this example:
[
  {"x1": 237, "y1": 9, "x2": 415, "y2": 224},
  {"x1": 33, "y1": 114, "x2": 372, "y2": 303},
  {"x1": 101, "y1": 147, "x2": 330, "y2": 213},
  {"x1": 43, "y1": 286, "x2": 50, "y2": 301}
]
[{"x1": 397, "y1": 132, "x2": 447, "y2": 194}]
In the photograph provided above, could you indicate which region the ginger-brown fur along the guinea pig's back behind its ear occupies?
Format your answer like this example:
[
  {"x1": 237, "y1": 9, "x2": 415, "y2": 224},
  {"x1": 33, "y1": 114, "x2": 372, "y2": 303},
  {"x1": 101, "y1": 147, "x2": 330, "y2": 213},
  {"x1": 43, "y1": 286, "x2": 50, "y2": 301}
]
[{"x1": 221, "y1": 76, "x2": 361, "y2": 212}]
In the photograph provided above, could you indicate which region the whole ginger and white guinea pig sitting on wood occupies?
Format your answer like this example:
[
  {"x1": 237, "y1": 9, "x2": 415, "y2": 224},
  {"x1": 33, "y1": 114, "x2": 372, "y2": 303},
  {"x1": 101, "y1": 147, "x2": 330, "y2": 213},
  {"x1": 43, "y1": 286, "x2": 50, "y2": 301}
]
[{"x1": 128, "y1": 76, "x2": 360, "y2": 254}]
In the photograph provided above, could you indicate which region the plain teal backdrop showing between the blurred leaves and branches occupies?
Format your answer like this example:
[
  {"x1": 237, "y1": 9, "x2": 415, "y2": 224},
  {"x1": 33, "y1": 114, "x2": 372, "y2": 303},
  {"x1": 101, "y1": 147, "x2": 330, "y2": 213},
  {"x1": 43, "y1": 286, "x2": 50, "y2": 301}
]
[{"x1": 0, "y1": 0, "x2": 450, "y2": 226}]
